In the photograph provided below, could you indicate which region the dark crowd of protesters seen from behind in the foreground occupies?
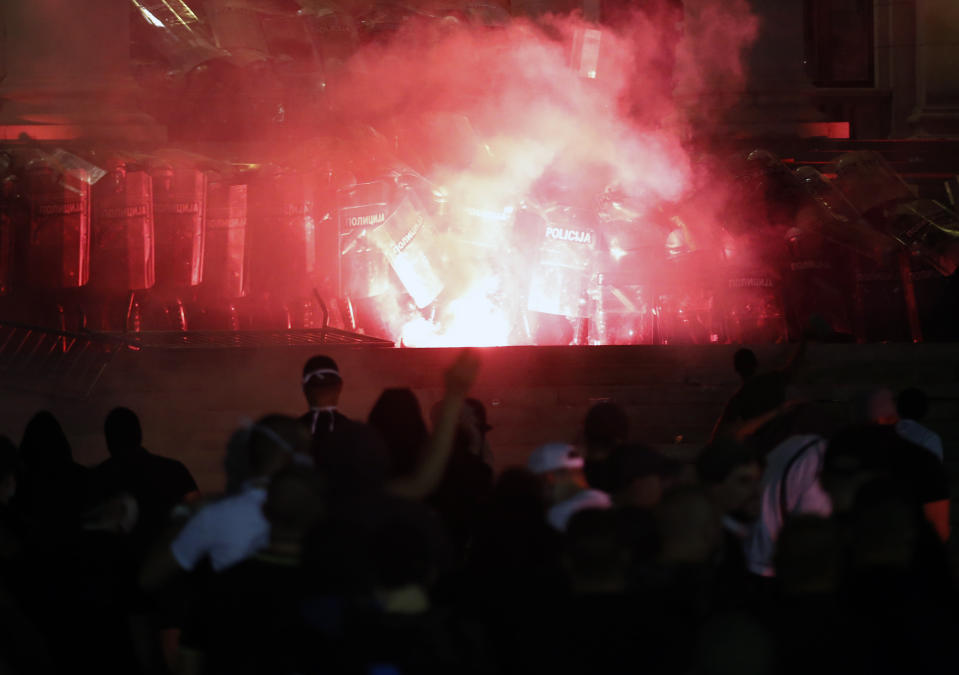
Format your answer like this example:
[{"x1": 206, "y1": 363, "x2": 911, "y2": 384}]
[{"x1": 0, "y1": 346, "x2": 959, "y2": 675}]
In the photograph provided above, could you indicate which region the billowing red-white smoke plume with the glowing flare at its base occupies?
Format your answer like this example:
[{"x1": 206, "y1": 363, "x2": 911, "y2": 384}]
[{"x1": 304, "y1": 0, "x2": 757, "y2": 346}]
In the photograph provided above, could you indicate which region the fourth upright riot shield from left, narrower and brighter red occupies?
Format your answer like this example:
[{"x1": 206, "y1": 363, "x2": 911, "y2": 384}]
[{"x1": 203, "y1": 181, "x2": 249, "y2": 300}]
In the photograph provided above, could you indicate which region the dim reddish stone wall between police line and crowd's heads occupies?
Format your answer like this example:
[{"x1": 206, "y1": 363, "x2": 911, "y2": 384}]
[{"x1": 0, "y1": 344, "x2": 959, "y2": 490}]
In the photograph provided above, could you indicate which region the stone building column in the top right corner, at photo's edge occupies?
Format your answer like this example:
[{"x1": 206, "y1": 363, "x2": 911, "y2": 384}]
[{"x1": 909, "y1": 0, "x2": 959, "y2": 136}]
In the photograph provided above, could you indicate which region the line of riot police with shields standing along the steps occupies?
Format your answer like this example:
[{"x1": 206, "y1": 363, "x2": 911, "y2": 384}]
[{"x1": 0, "y1": 147, "x2": 959, "y2": 344}]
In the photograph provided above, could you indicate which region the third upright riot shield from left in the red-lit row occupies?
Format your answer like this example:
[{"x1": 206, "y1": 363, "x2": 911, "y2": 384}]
[{"x1": 152, "y1": 166, "x2": 207, "y2": 289}]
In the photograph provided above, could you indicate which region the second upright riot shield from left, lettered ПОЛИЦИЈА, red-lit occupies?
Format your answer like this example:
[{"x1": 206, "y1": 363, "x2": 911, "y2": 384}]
[{"x1": 91, "y1": 164, "x2": 156, "y2": 291}]
